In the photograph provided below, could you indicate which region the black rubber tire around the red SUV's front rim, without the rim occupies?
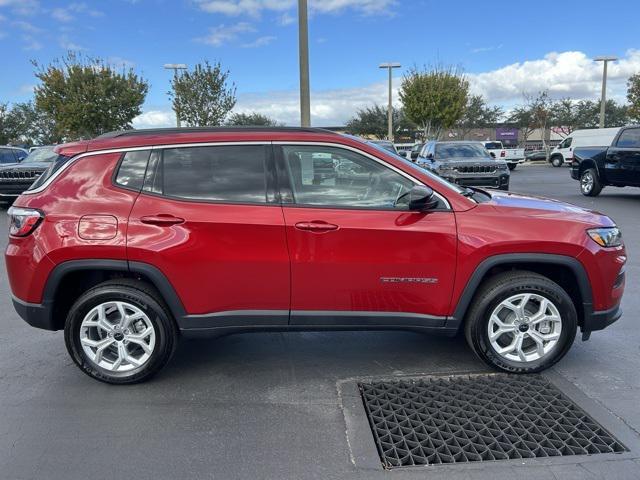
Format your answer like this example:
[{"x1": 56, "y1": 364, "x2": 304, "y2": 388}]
[{"x1": 465, "y1": 271, "x2": 578, "y2": 373}]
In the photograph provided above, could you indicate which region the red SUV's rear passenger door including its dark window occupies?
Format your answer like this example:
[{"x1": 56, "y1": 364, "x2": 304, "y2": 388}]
[{"x1": 127, "y1": 144, "x2": 290, "y2": 328}]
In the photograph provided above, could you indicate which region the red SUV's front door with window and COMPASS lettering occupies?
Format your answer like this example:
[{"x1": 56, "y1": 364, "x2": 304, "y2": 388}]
[{"x1": 276, "y1": 145, "x2": 456, "y2": 327}]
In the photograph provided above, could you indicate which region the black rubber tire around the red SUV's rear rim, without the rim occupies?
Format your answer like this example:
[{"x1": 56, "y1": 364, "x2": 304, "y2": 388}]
[{"x1": 64, "y1": 279, "x2": 178, "y2": 384}]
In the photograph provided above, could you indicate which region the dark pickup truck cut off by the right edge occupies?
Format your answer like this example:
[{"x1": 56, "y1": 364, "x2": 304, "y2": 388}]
[{"x1": 571, "y1": 126, "x2": 640, "y2": 197}]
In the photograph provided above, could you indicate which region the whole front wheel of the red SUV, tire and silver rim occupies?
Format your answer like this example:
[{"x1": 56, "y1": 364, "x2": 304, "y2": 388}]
[{"x1": 465, "y1": 271, "x2": 577, "y2": 373}]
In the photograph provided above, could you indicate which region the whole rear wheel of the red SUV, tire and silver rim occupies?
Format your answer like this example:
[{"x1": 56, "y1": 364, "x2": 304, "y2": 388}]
[{"x1": 65, "y1": 279, "x2": 178, "y2": 384}]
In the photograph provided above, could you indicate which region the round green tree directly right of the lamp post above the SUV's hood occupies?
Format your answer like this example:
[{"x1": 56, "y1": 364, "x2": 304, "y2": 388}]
[{"x1": 400, "y1": 67, "x2": 469, "y2": 139}]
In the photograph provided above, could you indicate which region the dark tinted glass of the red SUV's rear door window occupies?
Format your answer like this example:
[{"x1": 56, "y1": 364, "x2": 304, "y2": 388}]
[{"x1": 144, "y1": 145, "x2": 270, "y2": 203}]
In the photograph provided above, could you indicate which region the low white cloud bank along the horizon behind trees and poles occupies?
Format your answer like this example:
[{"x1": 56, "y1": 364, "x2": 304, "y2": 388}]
[{"x1": 135, "y1": 50, "x2": 640, "y2": 128}]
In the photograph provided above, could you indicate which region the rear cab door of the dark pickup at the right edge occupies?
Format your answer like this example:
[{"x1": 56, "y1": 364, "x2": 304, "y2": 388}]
[{"x1": 605, "y1": 128, "x2": 640, "y2": 186}]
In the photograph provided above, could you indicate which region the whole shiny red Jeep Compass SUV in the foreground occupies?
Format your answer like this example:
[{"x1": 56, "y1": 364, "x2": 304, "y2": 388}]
[{"x1": 6, "y1": 128, "x2": 626, "y2": 383}]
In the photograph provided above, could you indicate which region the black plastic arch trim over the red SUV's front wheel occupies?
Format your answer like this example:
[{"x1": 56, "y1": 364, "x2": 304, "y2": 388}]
[{"x1": 446, "y1": 253, "x2": 594, "y2": 331}]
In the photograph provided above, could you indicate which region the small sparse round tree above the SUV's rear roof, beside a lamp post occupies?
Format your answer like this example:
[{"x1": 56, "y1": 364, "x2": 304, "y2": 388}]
[{"x1": 169, "y1": 61, "x2": 236, "y2": 127}]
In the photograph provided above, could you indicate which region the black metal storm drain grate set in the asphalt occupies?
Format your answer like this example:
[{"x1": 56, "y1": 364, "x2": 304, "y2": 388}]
[{"x1": 359, "y1": 375, "x2": 627, "y2": 468}]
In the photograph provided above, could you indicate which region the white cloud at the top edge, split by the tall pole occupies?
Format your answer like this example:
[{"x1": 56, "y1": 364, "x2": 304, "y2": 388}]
[{"x1": 196, "y1": 0, "x2": 397, "y2": 16}]
